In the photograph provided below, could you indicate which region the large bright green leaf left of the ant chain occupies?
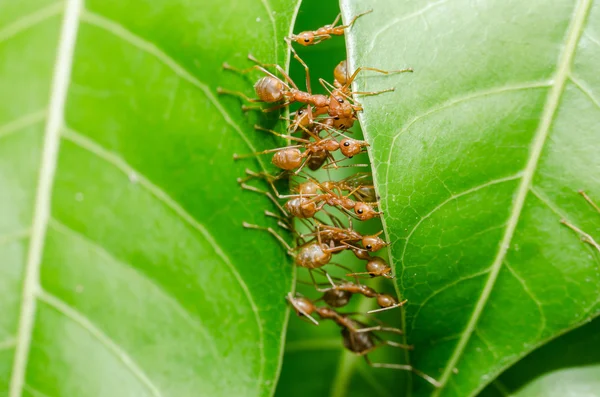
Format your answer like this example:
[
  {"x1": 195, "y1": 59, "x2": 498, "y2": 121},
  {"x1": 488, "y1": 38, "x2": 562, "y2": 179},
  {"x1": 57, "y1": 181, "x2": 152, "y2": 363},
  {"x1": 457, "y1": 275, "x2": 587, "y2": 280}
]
[{"x1": 0, "y1": 0, "x2": 297, "y2": 397}]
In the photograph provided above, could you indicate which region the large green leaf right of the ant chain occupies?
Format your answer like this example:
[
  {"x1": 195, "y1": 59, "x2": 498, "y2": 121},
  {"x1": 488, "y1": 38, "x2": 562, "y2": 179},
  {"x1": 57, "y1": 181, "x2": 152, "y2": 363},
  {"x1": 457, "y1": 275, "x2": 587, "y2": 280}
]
[{"x1": 341, "y1": 0, "x2": 600, "y2": 396}]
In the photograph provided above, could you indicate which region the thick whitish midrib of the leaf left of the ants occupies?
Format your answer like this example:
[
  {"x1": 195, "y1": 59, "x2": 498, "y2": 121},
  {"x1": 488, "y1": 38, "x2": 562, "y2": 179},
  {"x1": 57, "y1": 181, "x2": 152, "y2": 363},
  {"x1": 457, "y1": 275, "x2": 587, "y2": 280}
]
[{"x1": 9, "y1": 0, "x2": 83, "y2": 397}]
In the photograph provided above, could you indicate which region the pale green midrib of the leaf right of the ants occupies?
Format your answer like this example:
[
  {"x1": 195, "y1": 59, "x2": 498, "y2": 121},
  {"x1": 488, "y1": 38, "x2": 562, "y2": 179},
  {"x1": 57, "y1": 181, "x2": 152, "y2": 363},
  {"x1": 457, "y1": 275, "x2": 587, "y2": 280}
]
[{"x1": 432, "y1": 0, "x2": 593, "y2": 397}]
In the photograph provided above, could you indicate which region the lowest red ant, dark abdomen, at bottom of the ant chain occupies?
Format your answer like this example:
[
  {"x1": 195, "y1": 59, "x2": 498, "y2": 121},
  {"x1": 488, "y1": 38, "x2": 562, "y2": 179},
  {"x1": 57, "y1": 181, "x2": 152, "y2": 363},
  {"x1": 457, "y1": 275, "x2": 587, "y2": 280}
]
[{"x1": 287, "y1": 294, "x2": 440, "y2": 387}]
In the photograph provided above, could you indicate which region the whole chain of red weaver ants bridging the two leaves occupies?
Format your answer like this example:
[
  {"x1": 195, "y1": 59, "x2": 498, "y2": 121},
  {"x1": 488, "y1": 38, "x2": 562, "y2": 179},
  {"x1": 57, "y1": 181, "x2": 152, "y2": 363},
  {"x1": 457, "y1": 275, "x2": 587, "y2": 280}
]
[{"x1": 218, "y1": 11, "x2": 437, "y2": 386}]
